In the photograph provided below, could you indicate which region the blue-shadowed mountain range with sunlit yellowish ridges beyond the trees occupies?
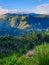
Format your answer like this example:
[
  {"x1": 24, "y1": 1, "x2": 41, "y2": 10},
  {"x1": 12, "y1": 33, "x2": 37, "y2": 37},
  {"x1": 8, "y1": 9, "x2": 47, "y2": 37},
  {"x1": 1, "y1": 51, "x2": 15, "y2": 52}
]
[{"x1": 0, "y1": 13, "x2": 49, "y2": 35}]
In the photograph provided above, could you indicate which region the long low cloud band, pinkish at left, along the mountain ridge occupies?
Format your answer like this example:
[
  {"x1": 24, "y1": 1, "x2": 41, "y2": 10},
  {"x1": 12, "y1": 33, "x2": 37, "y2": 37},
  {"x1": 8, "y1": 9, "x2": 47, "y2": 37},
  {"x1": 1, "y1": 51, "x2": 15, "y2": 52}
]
[{"x1": 0, "y1": 6, "x2": 31, "y2": 15}]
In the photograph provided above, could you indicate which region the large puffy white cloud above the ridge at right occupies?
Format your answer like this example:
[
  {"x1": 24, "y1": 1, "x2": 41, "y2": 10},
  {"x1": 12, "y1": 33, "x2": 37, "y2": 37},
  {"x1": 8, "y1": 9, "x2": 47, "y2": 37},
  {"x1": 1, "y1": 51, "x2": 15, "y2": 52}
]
[{"x1": 36, "y1": 4, "x2": 49, "y2": 14}]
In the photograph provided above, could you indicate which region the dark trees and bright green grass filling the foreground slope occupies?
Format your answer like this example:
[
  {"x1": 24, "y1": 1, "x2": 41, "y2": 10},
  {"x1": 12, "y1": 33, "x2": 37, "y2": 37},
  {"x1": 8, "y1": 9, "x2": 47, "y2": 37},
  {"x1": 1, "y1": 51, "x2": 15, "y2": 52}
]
[{"x1": 0, "y1": 31, "x2": 49, "y2": 65}]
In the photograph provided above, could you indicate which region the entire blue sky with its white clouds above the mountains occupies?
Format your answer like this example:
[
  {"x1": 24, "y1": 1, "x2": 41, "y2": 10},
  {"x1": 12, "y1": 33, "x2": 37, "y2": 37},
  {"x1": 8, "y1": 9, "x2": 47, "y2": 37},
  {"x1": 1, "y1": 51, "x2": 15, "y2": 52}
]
[{"x1": 0, "y1": 0, "x2": 49, "y2": 14}]
